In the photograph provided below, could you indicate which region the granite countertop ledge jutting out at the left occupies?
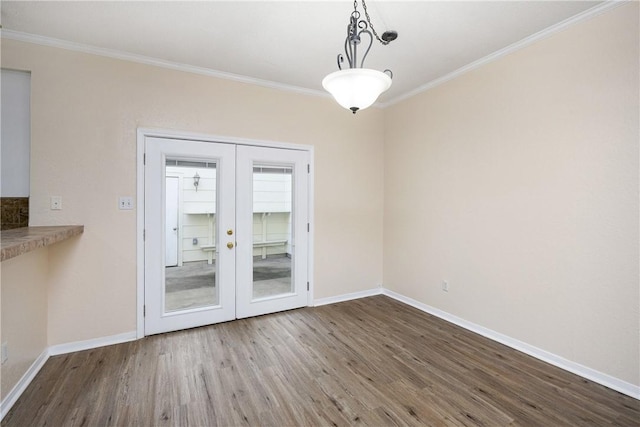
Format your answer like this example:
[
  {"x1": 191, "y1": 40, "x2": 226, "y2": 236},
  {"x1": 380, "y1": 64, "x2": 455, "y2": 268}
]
[{"x1": 0, "y1": 225, "x2": 84, "y2": 261}]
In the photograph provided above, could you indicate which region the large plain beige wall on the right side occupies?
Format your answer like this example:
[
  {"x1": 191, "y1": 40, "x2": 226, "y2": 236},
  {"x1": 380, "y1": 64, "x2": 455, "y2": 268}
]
[{"x1": 384, "y1": 2, "x2": 640, "y2": 385}]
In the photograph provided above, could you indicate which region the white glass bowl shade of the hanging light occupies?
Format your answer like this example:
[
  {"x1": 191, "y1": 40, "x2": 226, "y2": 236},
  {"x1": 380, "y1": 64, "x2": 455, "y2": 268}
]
[{"x1": 322, "y1": 68, "x2": 391, "y2": 113}]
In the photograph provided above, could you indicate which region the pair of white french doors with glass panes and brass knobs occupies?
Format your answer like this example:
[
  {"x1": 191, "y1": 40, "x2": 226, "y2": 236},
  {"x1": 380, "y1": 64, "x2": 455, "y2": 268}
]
[{"x1": 144, "y1": 137, "x2": 309, "y2": 335}]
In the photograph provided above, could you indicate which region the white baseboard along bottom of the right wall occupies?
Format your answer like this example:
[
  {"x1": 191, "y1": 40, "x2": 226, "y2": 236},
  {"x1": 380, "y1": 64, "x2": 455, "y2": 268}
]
[{"x1": 382, "y1": 288, "x2": 640, "y2": 400}]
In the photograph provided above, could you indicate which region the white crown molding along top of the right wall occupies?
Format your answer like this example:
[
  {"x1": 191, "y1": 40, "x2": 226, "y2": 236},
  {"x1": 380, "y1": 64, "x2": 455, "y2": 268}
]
[{"x1": 379, "y1": 0, "x2": 633, "y2": 108}]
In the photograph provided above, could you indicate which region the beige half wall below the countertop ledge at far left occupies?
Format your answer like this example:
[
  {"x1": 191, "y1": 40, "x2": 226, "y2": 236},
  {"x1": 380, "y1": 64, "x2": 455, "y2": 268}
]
[{"x1": 0, "y1": 248, "x2": 49, "y2": 399}]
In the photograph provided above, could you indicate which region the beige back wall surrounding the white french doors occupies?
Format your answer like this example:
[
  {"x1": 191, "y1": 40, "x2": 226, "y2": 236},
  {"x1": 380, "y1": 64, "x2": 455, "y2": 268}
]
[{"x1": 2, "y1": 39, "x2": 383, "y2": 345}]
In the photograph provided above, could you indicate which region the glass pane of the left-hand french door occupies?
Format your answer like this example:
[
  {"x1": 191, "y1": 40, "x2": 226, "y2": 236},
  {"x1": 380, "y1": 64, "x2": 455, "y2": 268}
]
[{"x1": 164, "y1": 158, "x2": 219, "y2": 313}]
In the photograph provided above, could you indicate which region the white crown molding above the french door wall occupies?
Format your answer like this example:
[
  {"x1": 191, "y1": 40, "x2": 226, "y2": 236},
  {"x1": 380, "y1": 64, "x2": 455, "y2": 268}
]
[{"x1": 0, "y1": 28, "x2": 330, "y2": 98}]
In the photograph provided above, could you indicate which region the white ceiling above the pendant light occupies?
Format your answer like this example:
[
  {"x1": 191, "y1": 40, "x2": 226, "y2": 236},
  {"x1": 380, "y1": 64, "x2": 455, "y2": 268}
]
[{"x1": 0, "y1": 0, "x2": 601, "y2": 103}]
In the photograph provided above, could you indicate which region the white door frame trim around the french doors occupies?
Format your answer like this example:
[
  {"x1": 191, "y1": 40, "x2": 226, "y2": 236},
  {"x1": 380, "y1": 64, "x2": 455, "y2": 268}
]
[{"x1": 136, "y1": 128, "x2": 314, "y2": 339}]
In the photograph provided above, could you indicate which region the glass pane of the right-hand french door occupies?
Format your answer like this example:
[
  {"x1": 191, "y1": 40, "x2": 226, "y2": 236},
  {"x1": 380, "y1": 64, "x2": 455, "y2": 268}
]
[{"x1": 252, "y1": 164, "x2": 294, "y2": 299}]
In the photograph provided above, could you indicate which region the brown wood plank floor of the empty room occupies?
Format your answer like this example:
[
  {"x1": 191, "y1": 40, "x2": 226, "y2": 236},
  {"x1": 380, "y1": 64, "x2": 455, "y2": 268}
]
[{"x1": 2, "y1": 296, "x2": 640, "y2": 427}]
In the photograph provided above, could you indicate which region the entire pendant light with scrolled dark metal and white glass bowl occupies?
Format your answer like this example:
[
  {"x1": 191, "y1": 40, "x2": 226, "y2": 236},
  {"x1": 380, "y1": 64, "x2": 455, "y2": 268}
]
[{"x1": 322, "y1": 0, "x2": 398, "y2": 114}]
